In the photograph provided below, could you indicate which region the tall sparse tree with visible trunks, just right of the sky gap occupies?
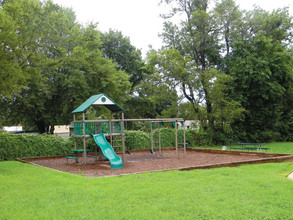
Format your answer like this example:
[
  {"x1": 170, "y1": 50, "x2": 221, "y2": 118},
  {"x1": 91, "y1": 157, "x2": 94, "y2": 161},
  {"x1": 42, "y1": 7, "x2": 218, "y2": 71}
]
[{"x1": 162, "y1": 0, "x2": 219, "y2": 124}]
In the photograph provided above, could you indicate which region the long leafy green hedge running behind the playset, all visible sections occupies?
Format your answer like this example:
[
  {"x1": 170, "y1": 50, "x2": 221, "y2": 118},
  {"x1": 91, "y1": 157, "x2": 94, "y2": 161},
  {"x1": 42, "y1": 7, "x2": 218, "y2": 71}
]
[{"x1": 0, "y1": 128, "x2": 196, "y2": 160}]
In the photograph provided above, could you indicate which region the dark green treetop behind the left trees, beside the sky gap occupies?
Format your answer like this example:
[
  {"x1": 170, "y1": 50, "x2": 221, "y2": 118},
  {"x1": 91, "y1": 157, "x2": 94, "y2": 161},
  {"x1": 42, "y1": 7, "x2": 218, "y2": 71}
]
[{"x1": 100, "y1": 29, "x2": 145, "y2": 89}]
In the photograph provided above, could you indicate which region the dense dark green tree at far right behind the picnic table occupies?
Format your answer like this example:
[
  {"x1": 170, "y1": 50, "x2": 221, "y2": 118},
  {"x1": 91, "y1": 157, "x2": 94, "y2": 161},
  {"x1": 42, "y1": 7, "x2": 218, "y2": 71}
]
[{"x1": 229, "y1": 33, "x2": 292, "y2": 141}]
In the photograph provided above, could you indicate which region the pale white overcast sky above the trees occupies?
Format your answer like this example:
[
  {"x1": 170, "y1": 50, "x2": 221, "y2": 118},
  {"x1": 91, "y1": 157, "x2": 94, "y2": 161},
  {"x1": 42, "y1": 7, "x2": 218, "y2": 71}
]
[{"x1": 53, "y1": 0, "x2": 293, "y2": 57}]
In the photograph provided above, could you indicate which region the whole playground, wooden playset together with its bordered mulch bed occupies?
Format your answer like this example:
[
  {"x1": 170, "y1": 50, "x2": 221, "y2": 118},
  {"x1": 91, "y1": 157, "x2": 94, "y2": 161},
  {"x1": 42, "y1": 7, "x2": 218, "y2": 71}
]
[{"x1": 17, "y1": 94, "x2": 293, "y2": 177}]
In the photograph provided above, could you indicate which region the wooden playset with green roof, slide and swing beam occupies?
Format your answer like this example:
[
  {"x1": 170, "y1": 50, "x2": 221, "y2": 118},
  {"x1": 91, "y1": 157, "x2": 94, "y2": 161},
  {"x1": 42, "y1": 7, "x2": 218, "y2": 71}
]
[{"x1": 66, "y1": 93, "x2": 186, "y2": 169}]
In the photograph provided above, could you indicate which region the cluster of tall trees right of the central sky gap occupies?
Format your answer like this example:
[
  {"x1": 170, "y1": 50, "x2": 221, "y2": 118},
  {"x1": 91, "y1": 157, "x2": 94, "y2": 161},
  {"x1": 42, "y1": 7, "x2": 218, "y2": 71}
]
[{"x1": 148, "y1": 0, "x2": 293, "y2": 141}]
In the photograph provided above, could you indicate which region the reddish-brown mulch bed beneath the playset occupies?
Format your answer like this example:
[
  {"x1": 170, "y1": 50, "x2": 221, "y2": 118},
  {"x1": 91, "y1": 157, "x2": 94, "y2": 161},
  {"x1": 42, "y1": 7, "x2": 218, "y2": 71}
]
[{"x1": 23, "y1": 149, "x2": 272, "y2": 177}]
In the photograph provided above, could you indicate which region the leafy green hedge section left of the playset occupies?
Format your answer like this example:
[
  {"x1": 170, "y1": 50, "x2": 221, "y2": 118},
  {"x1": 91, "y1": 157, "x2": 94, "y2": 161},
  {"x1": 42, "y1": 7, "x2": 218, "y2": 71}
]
[{"x1": 0, "y1": 132, "x2": 73, "y2": 160}]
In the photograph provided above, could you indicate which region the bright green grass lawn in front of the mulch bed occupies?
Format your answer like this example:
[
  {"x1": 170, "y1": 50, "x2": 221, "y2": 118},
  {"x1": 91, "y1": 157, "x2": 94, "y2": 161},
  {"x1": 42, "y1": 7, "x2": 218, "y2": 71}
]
[{"x1": 0, "y1": 144, "x2": 293, "y2": 219}]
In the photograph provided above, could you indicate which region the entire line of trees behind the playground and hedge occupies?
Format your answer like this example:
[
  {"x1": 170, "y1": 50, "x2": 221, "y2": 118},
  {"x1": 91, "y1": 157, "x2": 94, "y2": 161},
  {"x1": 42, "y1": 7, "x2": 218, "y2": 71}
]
[{"x1": 0, "y1": 0, "x2": 293, "y2": 143}]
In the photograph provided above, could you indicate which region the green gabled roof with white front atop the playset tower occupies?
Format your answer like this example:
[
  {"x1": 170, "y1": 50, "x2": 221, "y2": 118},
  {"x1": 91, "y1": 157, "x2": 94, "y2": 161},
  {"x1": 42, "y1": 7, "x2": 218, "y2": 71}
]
[{"x1": 72, "y1": 93, "x2": 125, "y2": 114}]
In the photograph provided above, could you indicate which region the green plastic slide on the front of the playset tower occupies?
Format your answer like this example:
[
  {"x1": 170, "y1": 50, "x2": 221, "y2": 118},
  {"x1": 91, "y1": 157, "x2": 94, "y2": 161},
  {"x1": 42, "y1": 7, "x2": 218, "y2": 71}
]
[{"x1": 92, "y1": 133, "x2": 123, "y2": 169}]
